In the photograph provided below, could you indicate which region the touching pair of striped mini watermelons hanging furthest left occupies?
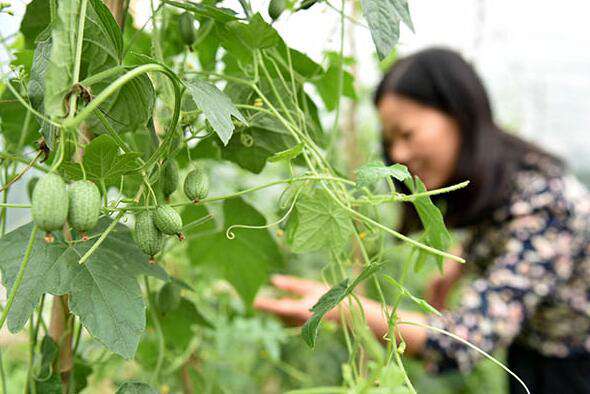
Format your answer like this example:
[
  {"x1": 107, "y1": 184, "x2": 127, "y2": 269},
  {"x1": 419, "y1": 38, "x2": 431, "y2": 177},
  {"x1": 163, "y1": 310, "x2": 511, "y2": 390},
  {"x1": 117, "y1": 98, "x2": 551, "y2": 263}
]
[{"x1": 31, "y1": 173, "x2": 100, "y2": 242}]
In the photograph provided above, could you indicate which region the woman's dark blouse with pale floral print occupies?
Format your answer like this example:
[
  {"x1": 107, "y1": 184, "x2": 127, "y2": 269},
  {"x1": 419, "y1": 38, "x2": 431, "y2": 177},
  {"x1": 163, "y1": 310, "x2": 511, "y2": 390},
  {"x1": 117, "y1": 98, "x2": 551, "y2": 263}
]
[{"x1": 423, "y1": 157, "x2": 590, "y2": 371}]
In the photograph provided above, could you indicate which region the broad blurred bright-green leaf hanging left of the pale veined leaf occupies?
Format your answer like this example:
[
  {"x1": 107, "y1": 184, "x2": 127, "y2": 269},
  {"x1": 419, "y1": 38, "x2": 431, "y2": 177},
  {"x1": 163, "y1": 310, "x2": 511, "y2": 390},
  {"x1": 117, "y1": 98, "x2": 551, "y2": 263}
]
[{"x1": 189, "y1": 198, "x2": 283, "y2": 307}]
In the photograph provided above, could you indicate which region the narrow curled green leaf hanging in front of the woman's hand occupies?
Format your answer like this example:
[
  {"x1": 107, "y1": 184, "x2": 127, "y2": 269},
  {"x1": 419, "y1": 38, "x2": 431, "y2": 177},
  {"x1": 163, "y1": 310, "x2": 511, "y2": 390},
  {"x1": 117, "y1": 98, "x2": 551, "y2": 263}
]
[{"x1": 301, "y1": 263, "x2": 383, "y2": 348}]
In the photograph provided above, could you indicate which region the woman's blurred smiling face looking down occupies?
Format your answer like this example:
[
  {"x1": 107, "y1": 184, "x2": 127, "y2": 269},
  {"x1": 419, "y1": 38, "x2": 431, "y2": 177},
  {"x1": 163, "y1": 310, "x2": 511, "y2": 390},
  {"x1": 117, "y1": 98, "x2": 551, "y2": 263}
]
[{"x1": 378, "y1": 94, "x2": 461, "y2": 189}]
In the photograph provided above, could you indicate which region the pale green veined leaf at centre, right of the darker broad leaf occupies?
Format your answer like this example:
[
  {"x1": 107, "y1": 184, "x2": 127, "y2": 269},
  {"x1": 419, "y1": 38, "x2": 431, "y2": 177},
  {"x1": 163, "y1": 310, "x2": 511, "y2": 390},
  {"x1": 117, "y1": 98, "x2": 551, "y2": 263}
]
[{"x1": 287, "y1": 188, "x2": 354, "y2": 253}]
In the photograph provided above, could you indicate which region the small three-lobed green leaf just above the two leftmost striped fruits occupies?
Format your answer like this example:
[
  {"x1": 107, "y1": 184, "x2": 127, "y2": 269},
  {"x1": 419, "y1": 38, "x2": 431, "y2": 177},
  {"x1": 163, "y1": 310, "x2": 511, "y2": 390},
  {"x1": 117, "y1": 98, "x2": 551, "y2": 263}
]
[{"x1": 62, "y1": 134, "x2": 141, "y2": 186}]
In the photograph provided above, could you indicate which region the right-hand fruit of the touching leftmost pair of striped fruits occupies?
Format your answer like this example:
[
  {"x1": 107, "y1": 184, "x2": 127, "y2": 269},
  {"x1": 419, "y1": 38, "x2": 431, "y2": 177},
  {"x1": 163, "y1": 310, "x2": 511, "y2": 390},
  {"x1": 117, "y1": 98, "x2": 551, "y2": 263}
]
[{"x1": 68, "y1": 181, "x2": 100, "y2": 240}]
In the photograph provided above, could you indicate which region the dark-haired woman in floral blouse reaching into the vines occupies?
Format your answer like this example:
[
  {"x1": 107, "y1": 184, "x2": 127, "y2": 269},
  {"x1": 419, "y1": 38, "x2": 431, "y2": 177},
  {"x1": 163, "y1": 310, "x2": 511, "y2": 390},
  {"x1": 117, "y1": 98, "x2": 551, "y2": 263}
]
[{"x1": 256, "y1": 48, "x2": 590, "y2": 393}]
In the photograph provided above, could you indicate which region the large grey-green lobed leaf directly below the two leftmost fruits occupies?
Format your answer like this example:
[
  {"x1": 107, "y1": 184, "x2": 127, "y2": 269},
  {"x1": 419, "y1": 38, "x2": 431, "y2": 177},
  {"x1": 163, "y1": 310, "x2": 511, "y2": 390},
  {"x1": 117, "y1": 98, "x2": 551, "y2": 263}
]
[{"x1": 0, "y1": 218, "x2": 167, "y2": 358}]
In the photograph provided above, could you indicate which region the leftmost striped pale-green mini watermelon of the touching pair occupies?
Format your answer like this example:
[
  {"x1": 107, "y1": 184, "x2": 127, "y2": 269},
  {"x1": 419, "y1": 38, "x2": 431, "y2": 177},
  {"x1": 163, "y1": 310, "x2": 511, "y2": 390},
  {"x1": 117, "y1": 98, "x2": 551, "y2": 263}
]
[{"x1": 31, "y1": 174, "x2": 68, "y2": 242}]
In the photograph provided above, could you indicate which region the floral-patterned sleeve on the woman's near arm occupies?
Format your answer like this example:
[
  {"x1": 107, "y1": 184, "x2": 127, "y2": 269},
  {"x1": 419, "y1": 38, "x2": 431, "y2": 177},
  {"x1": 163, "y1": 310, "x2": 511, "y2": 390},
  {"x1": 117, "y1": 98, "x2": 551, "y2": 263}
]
[{"x1": 423, "y1": 207, "x2": 572, "y2": 372}]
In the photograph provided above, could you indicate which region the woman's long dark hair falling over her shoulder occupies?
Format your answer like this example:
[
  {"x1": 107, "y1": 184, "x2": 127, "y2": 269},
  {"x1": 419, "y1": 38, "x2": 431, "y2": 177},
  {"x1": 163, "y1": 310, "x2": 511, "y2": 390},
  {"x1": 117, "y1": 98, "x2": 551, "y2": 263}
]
[{"x1": 374, "y1": 48, "x2": 563, "y2": 232}]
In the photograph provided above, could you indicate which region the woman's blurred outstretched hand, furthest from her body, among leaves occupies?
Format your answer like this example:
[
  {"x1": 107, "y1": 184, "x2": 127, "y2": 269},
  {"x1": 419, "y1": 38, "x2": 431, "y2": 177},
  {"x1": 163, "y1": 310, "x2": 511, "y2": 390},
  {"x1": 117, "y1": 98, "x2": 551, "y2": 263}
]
[{"x1": 254, "y1": 275, "x2": 338, "y2": 325}]
